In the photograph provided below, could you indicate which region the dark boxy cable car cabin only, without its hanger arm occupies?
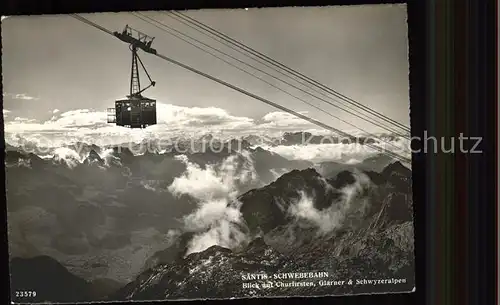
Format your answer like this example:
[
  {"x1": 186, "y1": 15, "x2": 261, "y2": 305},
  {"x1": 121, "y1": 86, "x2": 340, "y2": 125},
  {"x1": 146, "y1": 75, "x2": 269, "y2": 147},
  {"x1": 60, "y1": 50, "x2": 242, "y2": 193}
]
[{"x1": 108, "y1": 97, "x2": 156, "y2": 128}]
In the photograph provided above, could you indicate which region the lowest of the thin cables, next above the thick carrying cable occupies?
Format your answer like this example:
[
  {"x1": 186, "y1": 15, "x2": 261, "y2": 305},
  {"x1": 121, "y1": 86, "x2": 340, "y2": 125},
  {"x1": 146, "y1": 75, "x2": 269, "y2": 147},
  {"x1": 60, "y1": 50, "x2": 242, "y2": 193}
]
[{"x1": 132, "y1": 13, "x2": 406, "y2": 149}]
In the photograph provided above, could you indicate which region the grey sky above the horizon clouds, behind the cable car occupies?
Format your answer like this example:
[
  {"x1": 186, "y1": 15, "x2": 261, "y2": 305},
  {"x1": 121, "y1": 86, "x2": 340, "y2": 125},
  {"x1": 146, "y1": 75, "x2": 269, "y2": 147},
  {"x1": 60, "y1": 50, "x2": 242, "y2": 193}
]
[{"x1": 2, "y1": 5, "x2": 409, "y2": 137}]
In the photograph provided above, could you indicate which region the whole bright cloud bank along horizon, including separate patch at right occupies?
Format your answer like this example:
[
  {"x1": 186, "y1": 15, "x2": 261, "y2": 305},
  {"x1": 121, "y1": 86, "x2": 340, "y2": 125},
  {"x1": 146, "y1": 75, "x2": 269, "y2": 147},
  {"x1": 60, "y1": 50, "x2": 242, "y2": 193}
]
[{"x1": 4, "y1": 103, "x2": 409, "y2": 162}]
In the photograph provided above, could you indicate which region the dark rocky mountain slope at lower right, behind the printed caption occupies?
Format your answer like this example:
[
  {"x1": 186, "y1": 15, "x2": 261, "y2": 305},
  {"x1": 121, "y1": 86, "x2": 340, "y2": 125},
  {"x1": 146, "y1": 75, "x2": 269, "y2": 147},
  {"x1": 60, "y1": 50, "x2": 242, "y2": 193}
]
[{"x1": 113, "y1": 163, "x2": 414, "y2": 300}]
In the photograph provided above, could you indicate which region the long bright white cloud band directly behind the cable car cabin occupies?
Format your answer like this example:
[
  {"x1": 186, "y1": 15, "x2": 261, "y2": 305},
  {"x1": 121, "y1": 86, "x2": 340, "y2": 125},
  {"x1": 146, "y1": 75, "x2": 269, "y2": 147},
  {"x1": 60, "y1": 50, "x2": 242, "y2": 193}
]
[{"x1": 5, "y1": 103, "x2": 328, "y2": 144}]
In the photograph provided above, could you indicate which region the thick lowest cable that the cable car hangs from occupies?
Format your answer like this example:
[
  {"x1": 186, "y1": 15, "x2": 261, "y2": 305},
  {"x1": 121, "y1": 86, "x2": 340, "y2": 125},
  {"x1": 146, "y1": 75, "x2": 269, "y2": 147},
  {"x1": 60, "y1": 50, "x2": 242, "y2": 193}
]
[{"x1": 72, "y1": 14, "x2": 411, "y2": 164}]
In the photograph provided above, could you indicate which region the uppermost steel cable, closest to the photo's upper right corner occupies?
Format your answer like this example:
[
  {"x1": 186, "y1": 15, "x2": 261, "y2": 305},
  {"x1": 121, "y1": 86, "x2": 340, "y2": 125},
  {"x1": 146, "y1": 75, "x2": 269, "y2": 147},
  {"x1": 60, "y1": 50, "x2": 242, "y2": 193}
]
[{"x1": 168, "y1": 12, "x2": 410, "y2": 133}]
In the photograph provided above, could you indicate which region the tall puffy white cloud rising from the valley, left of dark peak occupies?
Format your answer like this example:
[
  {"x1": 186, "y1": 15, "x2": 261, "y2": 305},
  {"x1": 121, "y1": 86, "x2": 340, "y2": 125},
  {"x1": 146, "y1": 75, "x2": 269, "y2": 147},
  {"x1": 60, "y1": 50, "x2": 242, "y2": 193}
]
[{"x1": 169, "y1": 155, "x2": 257, "y2": 255}]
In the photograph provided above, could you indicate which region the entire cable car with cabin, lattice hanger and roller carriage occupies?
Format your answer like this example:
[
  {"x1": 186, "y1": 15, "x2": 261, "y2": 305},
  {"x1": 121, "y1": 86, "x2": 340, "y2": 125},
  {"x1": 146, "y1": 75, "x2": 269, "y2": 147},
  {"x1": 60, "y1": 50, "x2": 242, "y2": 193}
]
[{"x1": 107, "y1": 25, "x2": 156, "y2": 128}]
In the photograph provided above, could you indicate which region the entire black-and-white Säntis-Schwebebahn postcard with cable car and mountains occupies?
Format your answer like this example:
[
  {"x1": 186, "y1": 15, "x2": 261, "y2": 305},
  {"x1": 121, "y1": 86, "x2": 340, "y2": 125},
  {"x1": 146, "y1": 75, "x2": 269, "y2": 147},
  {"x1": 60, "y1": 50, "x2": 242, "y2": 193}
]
[{"x1": 1, "y1": 4, "x2": 416, "y2": 304}]
